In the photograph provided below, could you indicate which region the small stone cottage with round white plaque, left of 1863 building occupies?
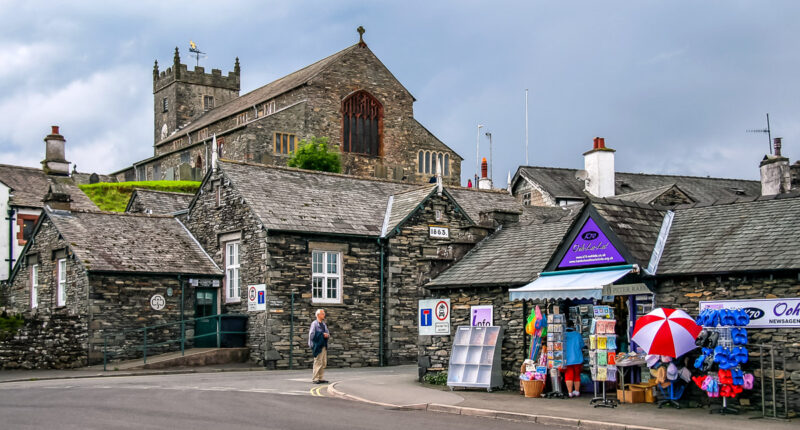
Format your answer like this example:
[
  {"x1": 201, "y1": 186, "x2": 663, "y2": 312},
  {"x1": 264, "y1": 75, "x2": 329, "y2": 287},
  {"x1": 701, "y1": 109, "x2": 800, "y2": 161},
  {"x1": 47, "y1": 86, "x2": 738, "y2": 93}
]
[{"x1": 0, "y1": 203, "x2": 222, "y2": 368}]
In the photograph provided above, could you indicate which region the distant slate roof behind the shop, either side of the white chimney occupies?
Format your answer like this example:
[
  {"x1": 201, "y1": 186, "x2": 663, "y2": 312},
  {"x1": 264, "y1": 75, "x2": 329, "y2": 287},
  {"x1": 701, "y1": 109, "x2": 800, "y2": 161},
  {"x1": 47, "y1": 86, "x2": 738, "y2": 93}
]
[{"x1": 514, "y1": 166, "x2": 761, "y2": 202}]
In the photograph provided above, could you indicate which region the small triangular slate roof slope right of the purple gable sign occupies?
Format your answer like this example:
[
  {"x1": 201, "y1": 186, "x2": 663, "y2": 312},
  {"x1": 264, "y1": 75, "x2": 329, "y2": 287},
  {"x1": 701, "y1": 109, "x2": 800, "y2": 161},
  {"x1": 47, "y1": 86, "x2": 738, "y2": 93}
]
[{"x1": 592, "y1": 199, "x2": 667, "y2": 268}]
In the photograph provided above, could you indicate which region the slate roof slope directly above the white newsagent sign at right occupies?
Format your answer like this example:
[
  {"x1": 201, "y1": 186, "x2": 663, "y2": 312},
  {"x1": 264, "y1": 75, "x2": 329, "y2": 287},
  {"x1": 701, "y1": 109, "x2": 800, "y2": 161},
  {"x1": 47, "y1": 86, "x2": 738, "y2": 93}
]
[{"x1": 656, "y1": 193, "x2": 800, "y2": 275}]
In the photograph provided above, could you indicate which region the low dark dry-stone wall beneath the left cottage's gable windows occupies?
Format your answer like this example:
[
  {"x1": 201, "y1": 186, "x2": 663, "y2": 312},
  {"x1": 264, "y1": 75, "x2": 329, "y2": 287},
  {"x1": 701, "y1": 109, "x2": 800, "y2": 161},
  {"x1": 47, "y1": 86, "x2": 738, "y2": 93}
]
[{"x1": 0, "y1": 313, "x2": 87, "y2": 369}]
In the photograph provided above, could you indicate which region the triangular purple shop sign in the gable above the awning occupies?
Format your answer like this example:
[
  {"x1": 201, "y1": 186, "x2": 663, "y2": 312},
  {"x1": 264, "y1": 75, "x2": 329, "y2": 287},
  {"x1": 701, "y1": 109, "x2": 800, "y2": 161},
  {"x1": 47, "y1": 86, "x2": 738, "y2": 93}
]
[{"x1": 558, "y1": 218, "x2": 625, "y2": 269}]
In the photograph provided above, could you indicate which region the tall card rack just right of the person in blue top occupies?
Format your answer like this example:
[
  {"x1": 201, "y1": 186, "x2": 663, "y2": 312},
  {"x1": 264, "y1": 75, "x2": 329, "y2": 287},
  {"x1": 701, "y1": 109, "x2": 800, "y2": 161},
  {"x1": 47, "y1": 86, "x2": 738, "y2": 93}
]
[{"x1": 589, "y1": 314, "x2": 619, "y2": 408}]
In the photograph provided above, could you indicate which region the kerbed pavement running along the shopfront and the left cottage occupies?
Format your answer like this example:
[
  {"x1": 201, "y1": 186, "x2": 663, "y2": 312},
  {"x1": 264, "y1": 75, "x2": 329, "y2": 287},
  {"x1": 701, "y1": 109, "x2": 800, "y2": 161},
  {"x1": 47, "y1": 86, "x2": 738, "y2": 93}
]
[{"x1": 0, "y1": 363, "x2": 798, "y2": 430}]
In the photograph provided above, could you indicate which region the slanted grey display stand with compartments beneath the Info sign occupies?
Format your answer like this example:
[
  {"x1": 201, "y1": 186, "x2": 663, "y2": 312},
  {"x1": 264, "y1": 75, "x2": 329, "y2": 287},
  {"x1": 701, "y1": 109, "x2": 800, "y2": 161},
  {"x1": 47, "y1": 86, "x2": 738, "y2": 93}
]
[{"x1": 447, "y1": 326, "x2": 503, "y2": 391}]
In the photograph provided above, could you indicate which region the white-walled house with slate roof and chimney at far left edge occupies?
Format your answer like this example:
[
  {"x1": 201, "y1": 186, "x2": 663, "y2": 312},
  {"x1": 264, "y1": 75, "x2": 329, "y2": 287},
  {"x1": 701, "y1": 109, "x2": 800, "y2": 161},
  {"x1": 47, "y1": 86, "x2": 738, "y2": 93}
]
[{"x1": 0, "y1": 126, "x2": 97, "y2": 282}]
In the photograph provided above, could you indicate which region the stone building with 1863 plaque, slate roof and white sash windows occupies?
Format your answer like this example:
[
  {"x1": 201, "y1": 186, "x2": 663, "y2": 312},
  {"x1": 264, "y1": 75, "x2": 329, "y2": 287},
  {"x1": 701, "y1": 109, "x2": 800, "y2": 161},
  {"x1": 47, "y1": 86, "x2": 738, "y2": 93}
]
[{"x1": 181, "y1": 161, "x2": 520, "y2": 368}]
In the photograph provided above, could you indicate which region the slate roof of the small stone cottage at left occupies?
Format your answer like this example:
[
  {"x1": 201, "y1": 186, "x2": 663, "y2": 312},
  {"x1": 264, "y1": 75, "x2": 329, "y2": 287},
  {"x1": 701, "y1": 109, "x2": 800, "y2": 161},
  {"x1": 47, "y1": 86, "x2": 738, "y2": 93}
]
[{"x1": 47, "y1": 211, "x2": 222, "y2": 276}]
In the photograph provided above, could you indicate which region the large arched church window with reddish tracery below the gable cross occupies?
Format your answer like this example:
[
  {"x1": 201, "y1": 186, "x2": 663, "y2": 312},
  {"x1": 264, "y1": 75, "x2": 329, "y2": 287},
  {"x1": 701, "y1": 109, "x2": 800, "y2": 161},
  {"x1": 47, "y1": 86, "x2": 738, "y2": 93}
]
[{"x1": 342, "y1": 91, "x2": 383, "y2": 156}]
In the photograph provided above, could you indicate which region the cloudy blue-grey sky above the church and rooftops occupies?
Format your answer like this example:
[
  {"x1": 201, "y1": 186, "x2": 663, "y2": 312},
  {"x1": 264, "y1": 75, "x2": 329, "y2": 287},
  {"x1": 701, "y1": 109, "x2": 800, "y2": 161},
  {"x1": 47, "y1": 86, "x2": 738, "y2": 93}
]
[{"x1": 0, "y1": 0, "x2": 800, "y2": 187}]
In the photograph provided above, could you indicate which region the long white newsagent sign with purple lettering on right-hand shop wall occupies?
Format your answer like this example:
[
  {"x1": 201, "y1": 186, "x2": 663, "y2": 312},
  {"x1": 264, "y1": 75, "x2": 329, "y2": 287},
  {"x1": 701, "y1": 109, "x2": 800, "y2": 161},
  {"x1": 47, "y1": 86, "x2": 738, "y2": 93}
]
[{"x1": 700, "y1": 298, "x2": 800, "y2": 328}]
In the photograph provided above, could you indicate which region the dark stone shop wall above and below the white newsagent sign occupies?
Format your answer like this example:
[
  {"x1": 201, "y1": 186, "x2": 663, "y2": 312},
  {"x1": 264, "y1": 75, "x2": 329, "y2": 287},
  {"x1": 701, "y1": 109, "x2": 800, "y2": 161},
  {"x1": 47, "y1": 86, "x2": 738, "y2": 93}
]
[{"x1": 655, "y1": 271, "x2": 800, "y2": 413}]
